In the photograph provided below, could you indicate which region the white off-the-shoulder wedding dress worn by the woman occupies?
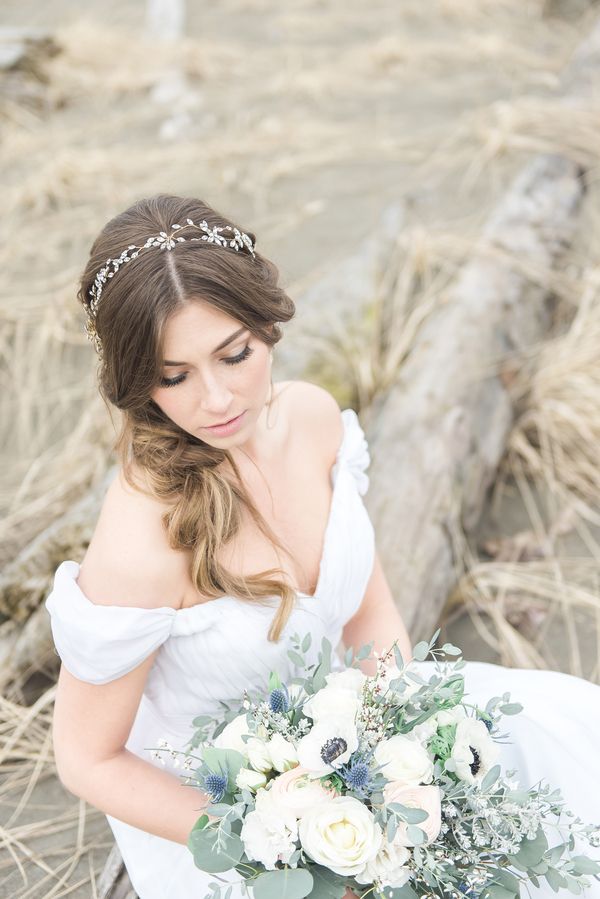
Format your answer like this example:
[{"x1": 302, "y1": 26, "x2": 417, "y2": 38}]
[{"x1": 46, "y1": 409, "x2": 600, "y2": 899}]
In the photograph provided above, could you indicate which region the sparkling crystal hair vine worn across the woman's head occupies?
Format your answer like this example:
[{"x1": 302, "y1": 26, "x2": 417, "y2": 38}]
[{"x1": 85, "y1": 219, "x2": 256, "y2": 355}]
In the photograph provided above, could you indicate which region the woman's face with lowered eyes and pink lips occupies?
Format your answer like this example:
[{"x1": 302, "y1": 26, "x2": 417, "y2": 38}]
[{"x1": 150, "y1": 300, "x2": 271, "y2": 449}]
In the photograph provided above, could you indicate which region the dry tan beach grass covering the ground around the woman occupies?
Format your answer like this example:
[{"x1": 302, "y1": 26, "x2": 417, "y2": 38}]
[{"x1": 0, "y1": 0, "x2": 600, "y2": 899}]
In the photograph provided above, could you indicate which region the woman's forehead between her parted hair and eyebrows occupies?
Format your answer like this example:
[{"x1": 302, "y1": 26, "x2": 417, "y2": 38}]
[{"x1": 163, "y1": 300, "x2": 242, "y2": 359}]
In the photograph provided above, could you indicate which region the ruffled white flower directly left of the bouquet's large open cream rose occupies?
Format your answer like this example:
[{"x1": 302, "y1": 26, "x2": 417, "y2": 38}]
[{"x1": 240, "y1": 789, "x2": 298, "y2": 871}]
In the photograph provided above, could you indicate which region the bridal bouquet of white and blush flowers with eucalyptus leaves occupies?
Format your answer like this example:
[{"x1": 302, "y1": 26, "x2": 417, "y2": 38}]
[{"x1": 154, "y1": 634, "x2": 600, "y2": 899}]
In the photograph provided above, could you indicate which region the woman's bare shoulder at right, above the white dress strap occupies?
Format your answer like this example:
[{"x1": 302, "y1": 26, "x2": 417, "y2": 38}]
[{"x1": 287, "y1": 381, "x2": 344, "y2": 466}]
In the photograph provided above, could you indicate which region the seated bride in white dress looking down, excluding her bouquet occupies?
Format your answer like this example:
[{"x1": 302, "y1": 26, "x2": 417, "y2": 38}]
[{"x1": 46, "y1": 195, "x2": 600, "y2": 899}]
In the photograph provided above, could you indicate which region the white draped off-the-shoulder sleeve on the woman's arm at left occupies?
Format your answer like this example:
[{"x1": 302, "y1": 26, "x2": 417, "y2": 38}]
[{"x1": 45, "y1": 560, "x2": 177, "y2": 684}]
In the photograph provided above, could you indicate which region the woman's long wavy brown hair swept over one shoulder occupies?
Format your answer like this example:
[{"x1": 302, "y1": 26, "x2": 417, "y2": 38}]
[{"x1": 77, "y1": 194, "x2": 295, "y2": 641}]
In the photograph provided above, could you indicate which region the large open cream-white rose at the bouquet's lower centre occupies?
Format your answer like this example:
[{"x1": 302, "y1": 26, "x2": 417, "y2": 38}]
[{"x1": 298, "y1": 796, "x2": 382, "y2": 876}]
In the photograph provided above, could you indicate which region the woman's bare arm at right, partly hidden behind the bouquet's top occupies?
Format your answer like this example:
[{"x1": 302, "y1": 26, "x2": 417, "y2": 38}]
[{"x1": 342, "y1": 552, "x2": 412, "y2": 675}]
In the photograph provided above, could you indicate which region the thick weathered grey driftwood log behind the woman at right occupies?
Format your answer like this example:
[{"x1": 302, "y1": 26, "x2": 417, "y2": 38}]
[{"x1": 366, "y1": 156, "x2": 583, "y2": 639}]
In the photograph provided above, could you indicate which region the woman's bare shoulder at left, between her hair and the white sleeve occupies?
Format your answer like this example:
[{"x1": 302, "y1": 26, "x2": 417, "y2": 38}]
[{"x1": 77, "y1": 468, "x2": 186, "y2": 608}]
